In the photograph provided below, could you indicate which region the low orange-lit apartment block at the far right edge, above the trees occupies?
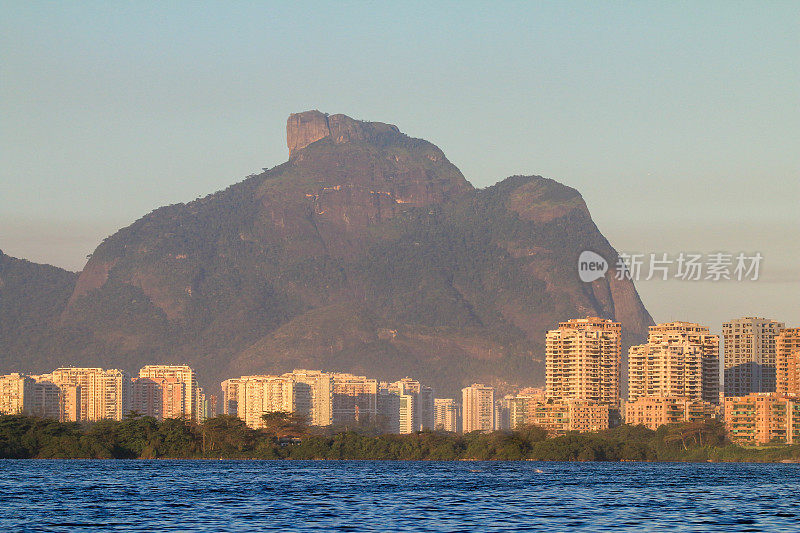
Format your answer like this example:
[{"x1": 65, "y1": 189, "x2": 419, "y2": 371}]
[{"x1": 724, "y1": 392, "x2": 800, "y2": 446}]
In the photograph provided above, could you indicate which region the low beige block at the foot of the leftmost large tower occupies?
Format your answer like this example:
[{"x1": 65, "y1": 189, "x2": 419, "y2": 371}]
[{"x1": 528, "y1": 399, "x2": 611, "y2": 436}]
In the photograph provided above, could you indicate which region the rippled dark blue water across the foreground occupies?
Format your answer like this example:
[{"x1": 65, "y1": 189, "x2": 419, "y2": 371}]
[{"x1": 0, "y1": 460, "x2": 800, "y2": 532}]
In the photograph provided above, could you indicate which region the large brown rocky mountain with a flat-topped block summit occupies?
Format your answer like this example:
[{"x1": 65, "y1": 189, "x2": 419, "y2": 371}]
[{"x1": 0, "y1": 111, "x2": 652, "y2": 394}]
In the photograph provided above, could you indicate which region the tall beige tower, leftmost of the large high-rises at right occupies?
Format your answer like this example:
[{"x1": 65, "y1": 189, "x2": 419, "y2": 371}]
[{"x1": 545, "y1": 317, "x2": 622, "y2": 407}]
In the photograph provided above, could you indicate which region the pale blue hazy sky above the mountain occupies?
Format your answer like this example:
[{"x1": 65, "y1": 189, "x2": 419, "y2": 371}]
[{"x1": 0, "y1": 1, "x2": 800, "y2": 329}]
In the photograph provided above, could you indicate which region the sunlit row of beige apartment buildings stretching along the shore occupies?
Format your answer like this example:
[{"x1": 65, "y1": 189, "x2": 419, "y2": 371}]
[{"x1": 6, "y1": 317, "x2": 800, "y2": 445}]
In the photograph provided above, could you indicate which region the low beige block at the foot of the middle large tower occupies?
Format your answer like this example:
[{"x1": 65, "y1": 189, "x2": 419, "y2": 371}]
[{"x1": 625, "y1": 396, "x2": 718, "y2": 430}]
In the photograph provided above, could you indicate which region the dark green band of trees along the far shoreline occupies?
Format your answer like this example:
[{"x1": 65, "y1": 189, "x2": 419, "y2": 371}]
[{"x1": 0, "y1": 413, "x2": 800, "y2": 462}]
